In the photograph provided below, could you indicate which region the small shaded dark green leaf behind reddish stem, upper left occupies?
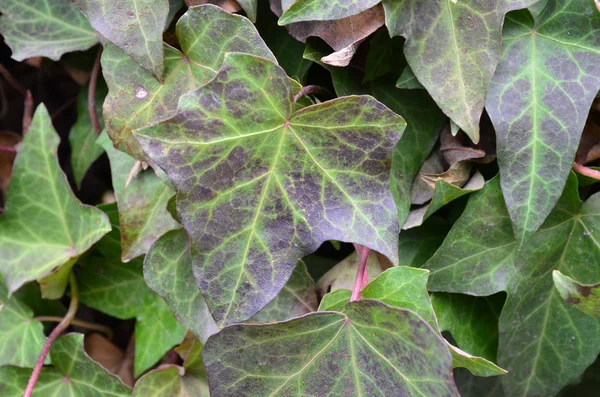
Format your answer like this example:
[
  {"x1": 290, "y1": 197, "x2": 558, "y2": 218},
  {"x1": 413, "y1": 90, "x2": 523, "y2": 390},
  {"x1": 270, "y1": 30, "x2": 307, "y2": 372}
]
[{"x1": 69, "y1": 81, "x2": 108, "y2": 188}]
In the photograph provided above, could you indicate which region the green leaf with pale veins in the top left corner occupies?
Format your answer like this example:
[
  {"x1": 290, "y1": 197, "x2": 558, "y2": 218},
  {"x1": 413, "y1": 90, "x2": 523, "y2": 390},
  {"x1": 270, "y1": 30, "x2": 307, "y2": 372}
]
[{"x1": 0, "y1": 0, "x2": 98, "y2": 61}]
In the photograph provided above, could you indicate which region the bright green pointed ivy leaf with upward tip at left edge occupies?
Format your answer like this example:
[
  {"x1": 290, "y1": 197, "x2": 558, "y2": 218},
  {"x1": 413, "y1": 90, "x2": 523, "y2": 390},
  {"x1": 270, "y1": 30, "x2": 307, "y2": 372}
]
[{"x1": 0, "y1": 105, "x2": 110, "y2": 293}]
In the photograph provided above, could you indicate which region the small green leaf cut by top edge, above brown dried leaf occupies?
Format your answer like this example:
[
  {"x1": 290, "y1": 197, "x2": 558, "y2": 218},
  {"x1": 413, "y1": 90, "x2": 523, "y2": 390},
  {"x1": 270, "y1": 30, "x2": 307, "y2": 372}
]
[{"x1": 279, "y1": 0, "x2": 381, "y2": 25}]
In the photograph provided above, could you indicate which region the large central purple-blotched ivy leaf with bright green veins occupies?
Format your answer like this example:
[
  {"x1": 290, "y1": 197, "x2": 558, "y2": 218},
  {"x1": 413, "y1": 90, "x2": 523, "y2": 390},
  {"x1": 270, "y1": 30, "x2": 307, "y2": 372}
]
[{"x1": 136, "y1": 54, "x2": 405, "y2": 326}]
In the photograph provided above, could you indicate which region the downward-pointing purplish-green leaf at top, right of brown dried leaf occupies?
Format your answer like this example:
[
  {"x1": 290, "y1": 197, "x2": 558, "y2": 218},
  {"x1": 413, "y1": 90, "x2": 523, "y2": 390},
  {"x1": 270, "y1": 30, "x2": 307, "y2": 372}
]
[{"x1": 383, "y1": 0, "x2": 537, "y2": 143}]
